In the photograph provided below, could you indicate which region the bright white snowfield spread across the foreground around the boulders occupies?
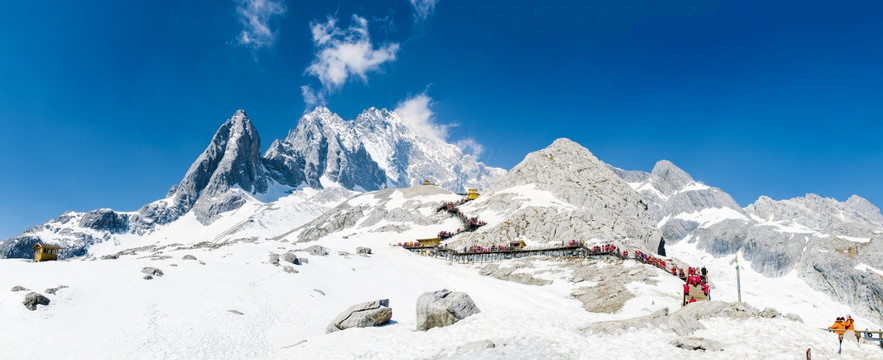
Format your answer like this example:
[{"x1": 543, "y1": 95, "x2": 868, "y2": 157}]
[{"x1": 0, "y1": 188, "x2": 883, "y2": 360}]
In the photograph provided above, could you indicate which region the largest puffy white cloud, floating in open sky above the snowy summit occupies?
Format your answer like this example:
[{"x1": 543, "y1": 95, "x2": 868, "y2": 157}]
[{"x1": 306, "y1": 15, "x2": 399, "y2": 96}]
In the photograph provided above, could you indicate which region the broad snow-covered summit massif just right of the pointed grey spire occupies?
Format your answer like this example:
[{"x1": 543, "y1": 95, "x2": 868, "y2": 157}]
[{"x1": 264, "y1": 107, "x2": 505, "y2": 191}]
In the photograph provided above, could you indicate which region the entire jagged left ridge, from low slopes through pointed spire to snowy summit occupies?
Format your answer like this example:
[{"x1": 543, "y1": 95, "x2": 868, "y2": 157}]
[{"x1": 0, "y1": 107, "x2": 505, "y2": 258}]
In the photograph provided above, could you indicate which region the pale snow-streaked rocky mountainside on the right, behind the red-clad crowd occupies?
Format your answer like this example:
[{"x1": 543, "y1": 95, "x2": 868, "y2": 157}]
[{"x1": 614, "y1": 160, "x2": 883, "y2": 320}]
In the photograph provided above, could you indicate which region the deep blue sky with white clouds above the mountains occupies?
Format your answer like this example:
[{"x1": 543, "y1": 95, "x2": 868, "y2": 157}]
[{"x1": 0, "y1": 0, "x2": 883, "y2": 239}]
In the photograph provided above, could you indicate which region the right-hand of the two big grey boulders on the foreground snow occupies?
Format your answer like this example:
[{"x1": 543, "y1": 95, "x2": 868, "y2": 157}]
[{"x1": 417, "y1": 289, "x2": 481, "y2": 331}]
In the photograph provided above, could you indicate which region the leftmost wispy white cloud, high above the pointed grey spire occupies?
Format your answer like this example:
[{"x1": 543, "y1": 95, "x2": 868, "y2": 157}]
[{"x1": 236, "y1": 0, "x2": 287, "y2": 49}]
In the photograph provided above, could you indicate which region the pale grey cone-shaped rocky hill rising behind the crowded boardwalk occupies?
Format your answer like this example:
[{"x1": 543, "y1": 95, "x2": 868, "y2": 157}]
[{"x1": 453, "y1": 139, "x2": 662, "y2": 252}]
